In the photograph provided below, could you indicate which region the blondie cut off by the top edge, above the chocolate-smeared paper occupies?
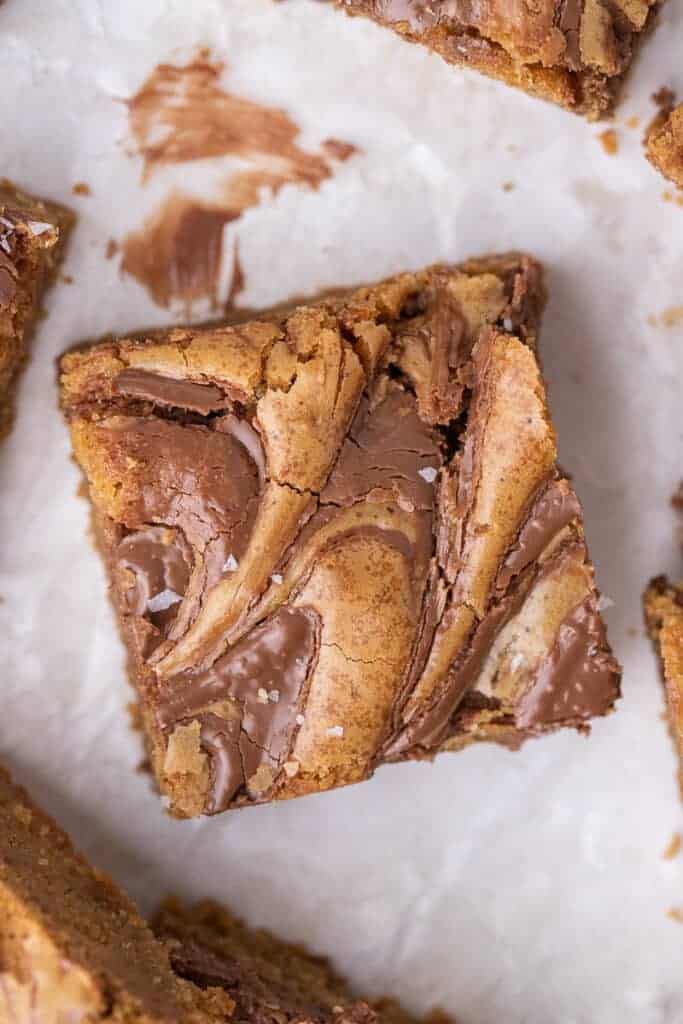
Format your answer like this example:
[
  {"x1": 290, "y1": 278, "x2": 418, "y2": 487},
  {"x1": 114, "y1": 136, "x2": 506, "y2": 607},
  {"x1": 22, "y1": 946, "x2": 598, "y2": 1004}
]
[{"x1": 334, "y1": 0, "x2": 657, "y2": 120}]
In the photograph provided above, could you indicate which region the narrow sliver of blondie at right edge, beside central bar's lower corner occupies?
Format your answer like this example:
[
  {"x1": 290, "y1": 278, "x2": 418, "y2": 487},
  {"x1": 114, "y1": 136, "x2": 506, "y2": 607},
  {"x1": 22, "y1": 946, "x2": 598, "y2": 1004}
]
[{"x1": 643, "y1": 577, "x2": 683, "y2": 796}]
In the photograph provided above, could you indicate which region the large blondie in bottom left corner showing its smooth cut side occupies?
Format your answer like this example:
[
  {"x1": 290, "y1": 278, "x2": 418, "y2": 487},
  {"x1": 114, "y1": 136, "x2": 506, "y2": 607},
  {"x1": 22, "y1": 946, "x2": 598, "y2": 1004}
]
[{"x1": 0, "y1": 769, "x2": 232, "y2": 1024}]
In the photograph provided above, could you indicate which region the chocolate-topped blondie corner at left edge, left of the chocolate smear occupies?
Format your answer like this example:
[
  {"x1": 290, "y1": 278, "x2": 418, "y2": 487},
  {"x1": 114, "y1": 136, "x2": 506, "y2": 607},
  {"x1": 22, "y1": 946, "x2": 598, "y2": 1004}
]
[{"x1": 0, "y1": 179, "x2": 73, "y2": 436}]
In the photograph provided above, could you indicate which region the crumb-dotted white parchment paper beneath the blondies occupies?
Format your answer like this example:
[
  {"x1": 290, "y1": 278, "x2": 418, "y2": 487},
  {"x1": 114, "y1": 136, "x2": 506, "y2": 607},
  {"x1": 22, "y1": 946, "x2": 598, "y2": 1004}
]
[{"x1": 0, "y1": 0, "x2": 683, "y2": 1024}]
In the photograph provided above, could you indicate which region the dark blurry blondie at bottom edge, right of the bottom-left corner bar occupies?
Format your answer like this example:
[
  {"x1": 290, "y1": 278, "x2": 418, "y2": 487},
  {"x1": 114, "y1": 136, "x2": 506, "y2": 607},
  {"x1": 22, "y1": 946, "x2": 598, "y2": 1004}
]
[{"x1": 152, "y1": 899, "x2": 423, "y2": 1024}]
